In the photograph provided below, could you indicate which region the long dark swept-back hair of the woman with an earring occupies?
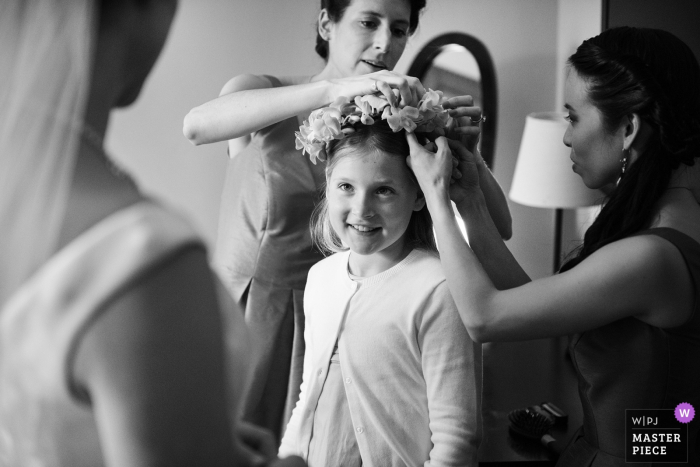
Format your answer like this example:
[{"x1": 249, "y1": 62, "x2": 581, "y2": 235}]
[{"x1": 561, "y1": 27, "x2": 700, "y2": 271}]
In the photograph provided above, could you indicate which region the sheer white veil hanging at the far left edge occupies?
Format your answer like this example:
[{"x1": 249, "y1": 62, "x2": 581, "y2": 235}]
[{"x1": 0, "y1": 0, "x2": 96, "y2": 304}]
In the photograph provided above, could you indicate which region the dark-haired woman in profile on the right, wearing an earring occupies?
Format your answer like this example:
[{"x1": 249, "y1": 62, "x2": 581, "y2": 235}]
[{"x1": 411, "y1": 28, "x2": 700, "y2": 467}]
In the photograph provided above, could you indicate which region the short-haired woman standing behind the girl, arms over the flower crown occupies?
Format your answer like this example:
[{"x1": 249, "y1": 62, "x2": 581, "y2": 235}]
[{"x1": 184, "y1": 0, "x2": 510, "y2": 437}]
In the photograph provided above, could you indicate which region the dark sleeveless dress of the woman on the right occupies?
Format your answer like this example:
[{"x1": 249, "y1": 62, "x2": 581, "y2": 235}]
[{"x1": 557, "y1": 228, "x2": 700, "y2": 467}]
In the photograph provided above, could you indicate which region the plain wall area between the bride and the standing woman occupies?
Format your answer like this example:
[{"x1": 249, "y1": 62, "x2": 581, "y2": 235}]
[{"x1": 107, "y1": 0, "x2": 321, "y2": 245}]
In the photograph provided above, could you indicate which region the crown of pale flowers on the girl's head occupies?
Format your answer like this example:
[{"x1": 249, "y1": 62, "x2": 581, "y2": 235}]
[{"x1": 294, "y1": 89, "x2": 452, "y2": 164}]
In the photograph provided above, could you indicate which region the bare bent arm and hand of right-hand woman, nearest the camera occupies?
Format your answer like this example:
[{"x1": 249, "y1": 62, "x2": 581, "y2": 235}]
[{"x1": 411, "y1": 135, "x2": 693, "y2": 341}]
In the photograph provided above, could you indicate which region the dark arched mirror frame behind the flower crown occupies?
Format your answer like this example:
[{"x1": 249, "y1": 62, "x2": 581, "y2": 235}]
[{"x1": 407, "y1": 32, "x2": 498, "y2": 168}]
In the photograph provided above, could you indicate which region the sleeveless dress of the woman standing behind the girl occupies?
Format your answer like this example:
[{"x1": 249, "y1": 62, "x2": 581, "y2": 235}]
[{"x1": 214, "y1": 76, "x2": 325, "y2": 440}]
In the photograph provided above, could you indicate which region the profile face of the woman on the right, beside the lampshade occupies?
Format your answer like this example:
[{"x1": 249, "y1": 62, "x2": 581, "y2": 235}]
[{"x1": 564, "y1": 68, "x2": 624, "y2": 188}]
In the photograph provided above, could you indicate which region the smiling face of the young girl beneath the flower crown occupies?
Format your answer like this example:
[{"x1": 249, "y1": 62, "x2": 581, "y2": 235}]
[{"x1": 326, "y1": 149, "x2": 425, "y2": 274}]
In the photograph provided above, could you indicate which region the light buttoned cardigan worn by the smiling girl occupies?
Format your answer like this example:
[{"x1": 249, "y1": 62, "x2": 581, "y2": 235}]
[{"x1": 279, "y1": 250, "x2": 481, "y2": 467}]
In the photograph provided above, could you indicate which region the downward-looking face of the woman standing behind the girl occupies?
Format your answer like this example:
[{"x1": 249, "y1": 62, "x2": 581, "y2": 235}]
[{"x1": 321, "y1": 0, "x2": 411, "y2": 77}]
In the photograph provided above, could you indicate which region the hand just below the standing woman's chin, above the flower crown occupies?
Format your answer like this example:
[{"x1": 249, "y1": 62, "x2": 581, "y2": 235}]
[{"x1": 328, "y1": 70, "x2": 425, "y2": 107}]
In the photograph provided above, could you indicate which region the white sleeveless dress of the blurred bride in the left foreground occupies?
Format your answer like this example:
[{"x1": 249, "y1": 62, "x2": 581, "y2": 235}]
[{"x1": 0, "y1": 201, "x2": 248, "y2": 467}]
